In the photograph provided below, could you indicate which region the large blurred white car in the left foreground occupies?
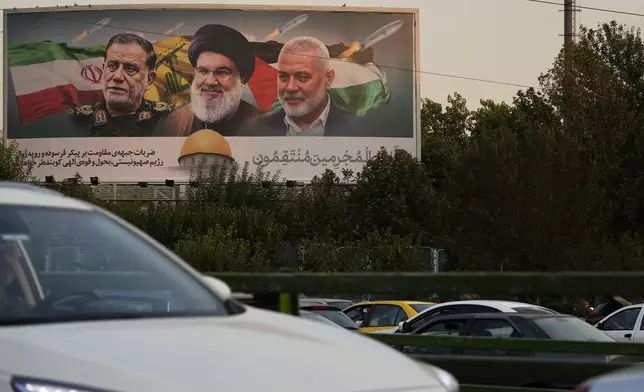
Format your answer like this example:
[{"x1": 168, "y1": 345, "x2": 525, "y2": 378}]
[{"x1": 0, "y1": 183, "x2": 458, "y2": 392}]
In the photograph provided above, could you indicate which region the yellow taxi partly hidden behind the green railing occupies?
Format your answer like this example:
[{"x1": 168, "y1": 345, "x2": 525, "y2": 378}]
[{"x1": 343, "y1": 301, "x2": 435, "y2": 333}]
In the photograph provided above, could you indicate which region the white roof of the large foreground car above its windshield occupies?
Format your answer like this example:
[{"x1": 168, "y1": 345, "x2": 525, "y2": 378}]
[{"x1": 0, "y1": 181, "x2": 94, "y2": 211}]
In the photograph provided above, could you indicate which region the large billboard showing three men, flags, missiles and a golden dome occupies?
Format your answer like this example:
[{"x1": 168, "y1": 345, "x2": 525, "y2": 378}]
[{"x1": 4, "y1": 6, "x2": 420, "y2": 183}]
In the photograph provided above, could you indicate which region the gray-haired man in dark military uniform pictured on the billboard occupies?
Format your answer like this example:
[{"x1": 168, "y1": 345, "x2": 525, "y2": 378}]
[{"x1": 69, "y1": 33, "x2": 171, "y2": 137}]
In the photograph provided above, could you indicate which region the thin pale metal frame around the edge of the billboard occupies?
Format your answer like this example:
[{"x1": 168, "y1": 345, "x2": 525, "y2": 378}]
[{"x1": 1, "y1": 4, "x2": 421, "y2": 185}]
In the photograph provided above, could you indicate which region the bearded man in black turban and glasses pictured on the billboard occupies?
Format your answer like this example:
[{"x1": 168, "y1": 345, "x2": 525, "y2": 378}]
[{"x1": 168, "y1": 24, "x2": 261, "y2": 136}]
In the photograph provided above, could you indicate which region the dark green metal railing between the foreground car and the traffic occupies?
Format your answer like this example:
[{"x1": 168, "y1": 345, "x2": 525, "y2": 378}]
[{"x1": 208, "y1": 272, "x2": 644, "y2": 392}]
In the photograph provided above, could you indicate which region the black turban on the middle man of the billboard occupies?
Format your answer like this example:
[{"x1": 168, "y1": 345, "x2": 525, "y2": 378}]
[{"x1": 188, "y1": 24, "x2": 255, "y2": 83}]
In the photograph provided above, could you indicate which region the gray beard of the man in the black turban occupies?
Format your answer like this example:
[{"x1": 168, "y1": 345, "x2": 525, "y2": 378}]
[{"x1": 190, "y1": 81, "x2": 244, "y2": 123}]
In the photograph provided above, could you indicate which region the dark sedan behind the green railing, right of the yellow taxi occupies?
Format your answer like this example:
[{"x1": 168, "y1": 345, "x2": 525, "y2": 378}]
[{"x1": 396, "y1": 313, "x2": 620, "y2": 389}]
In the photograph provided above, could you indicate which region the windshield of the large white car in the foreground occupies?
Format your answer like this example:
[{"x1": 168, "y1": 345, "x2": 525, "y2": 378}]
[{"x1": 0, "y1": 206, "x2": 227, "y2": 325}]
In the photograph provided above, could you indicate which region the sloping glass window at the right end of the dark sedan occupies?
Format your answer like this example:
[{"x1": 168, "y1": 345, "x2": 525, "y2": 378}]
[{"x1": 534, "y1": 317, "x2": 615, "y2": 342}]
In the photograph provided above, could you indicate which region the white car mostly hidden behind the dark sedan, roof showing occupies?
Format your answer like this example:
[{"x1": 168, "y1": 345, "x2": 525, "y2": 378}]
[{"x1": 372, "y1": 300, "x2": 557, "y2": 334}]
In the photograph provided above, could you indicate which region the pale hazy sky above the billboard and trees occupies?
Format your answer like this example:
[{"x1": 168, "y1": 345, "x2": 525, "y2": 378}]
[{"x1": 0, "y1": 0, "x2": 644, "y2": 136}]
